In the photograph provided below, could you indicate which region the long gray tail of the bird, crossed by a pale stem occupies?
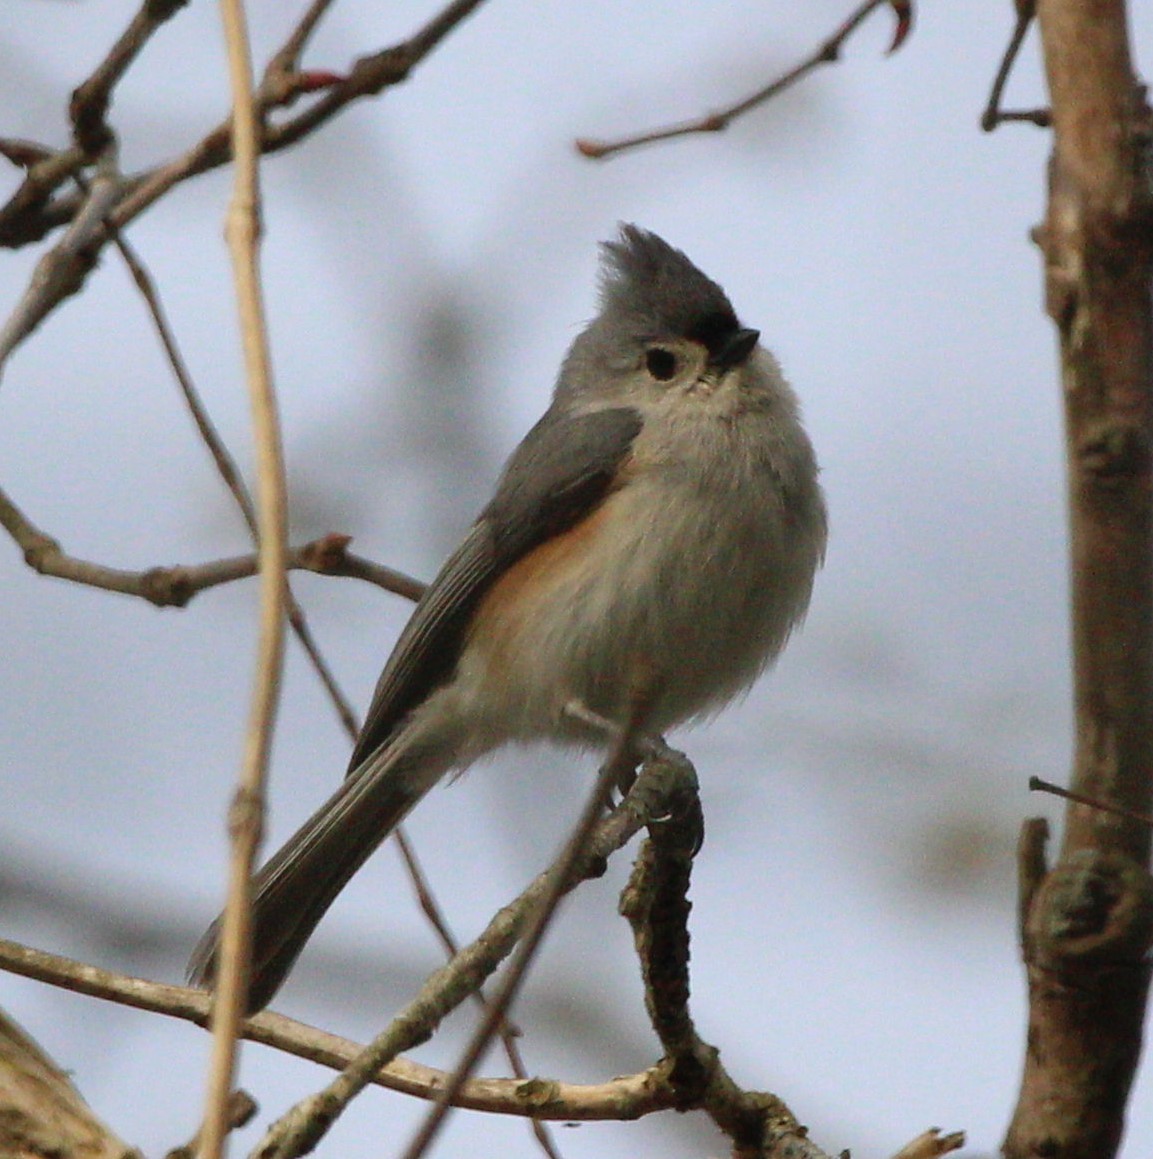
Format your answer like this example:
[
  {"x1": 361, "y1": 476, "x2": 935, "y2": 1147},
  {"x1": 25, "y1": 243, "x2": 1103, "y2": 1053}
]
[{"x1": 188, "y1": 743, "x2": 448, "y2": 1013}]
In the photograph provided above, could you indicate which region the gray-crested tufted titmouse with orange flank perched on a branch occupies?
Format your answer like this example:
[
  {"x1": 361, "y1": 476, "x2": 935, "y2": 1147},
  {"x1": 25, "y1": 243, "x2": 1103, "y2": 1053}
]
[{"x1": 189, "y1": 225, "x2": 826, "y2": 1011}]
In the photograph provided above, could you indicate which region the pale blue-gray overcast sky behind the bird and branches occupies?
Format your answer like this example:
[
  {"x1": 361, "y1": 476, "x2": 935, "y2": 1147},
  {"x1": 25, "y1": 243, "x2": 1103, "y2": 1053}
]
[{"x1": 0, "y1": 0, "x2": 1153, "y2": 1159}]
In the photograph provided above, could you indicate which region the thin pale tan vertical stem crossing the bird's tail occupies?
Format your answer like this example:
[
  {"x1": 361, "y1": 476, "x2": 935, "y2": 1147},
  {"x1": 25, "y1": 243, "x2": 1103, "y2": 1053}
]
[{"x1": 200, "y1": 0, "x2": 287, "y2": 1159}]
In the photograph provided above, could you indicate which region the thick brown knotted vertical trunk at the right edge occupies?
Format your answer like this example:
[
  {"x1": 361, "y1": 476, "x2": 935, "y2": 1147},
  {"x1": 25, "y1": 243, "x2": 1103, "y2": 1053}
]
[{"x1": 1004, "y1": 0, "x2": 1153, "y2": 1159}]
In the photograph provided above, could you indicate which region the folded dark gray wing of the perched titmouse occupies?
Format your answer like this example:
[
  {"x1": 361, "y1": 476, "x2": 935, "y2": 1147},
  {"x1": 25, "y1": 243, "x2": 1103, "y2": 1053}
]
[{"x1": 349, "y1": 407, "x2": 641, "y2": 772}]
